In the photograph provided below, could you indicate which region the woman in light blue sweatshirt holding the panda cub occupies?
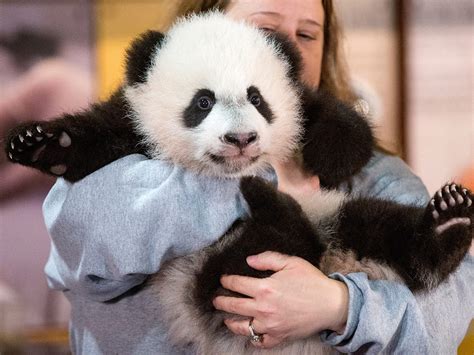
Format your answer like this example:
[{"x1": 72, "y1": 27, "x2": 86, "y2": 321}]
[{"x1": 41, "y1": 0, "x2": 474, "y2": 354}]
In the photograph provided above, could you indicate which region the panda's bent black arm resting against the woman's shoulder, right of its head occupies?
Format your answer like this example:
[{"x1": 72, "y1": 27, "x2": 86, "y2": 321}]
[{"x1": 303, "y1": 92, "x2": 375, "y2": 188}]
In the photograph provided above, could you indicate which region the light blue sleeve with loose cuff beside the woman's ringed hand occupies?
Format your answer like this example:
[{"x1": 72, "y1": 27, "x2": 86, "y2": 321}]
[{"x1": 321, "y1": 255, "x2": 474, "y2": 354}]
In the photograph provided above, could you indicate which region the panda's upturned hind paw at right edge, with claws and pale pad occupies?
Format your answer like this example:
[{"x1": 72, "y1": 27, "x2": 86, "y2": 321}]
[{"x1": 427, "y1": 184, "x2": 474, "y2": 235}]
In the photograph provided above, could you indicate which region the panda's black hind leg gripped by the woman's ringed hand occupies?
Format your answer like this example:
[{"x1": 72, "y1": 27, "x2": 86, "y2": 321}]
[{"x1": 194, "y1": 177, "x2": 325, "y2": 311}]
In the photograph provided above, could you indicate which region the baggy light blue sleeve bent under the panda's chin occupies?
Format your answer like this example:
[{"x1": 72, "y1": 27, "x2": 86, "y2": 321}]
[{"x1": 43, "y1": 155, "x2": 260, "y2": 301}]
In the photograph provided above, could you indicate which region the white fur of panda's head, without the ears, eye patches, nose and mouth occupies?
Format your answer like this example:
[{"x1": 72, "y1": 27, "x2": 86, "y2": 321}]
[{"x1": 126, "y1": 13, "x2": 301, "y2": 177}]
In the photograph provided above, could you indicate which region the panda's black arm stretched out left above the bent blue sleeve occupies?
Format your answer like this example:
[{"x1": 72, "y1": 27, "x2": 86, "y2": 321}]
[{"x1": 5, "y1": 89, "x2": 145, "y2": 181}]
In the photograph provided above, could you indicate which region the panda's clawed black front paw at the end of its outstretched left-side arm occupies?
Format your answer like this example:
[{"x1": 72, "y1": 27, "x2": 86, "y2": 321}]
[{"x1": 6, "y1": 122, "x2": 71, "y2": 176}]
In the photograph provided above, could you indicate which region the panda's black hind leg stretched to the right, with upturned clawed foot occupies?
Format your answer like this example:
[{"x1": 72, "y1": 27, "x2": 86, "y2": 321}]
[{"x1": 335, "y1": 184, "x2": 474, "y2": 291}]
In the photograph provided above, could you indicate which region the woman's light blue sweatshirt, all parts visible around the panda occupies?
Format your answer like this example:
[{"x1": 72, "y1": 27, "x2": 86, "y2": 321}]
[{"x1": 44, "y1": 153, "x2": 474, "y2": 354}]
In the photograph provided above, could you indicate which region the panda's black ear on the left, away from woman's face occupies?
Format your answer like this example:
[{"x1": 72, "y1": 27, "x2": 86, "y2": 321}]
[{"x1": 125, "y1": 30, "x2": 165, "y2": 85}]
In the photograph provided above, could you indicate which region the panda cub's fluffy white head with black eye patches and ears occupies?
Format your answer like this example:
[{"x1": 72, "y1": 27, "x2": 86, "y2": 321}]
[{"x1": 125, "y1": 13, "x2": 301, "y2": 177}]
